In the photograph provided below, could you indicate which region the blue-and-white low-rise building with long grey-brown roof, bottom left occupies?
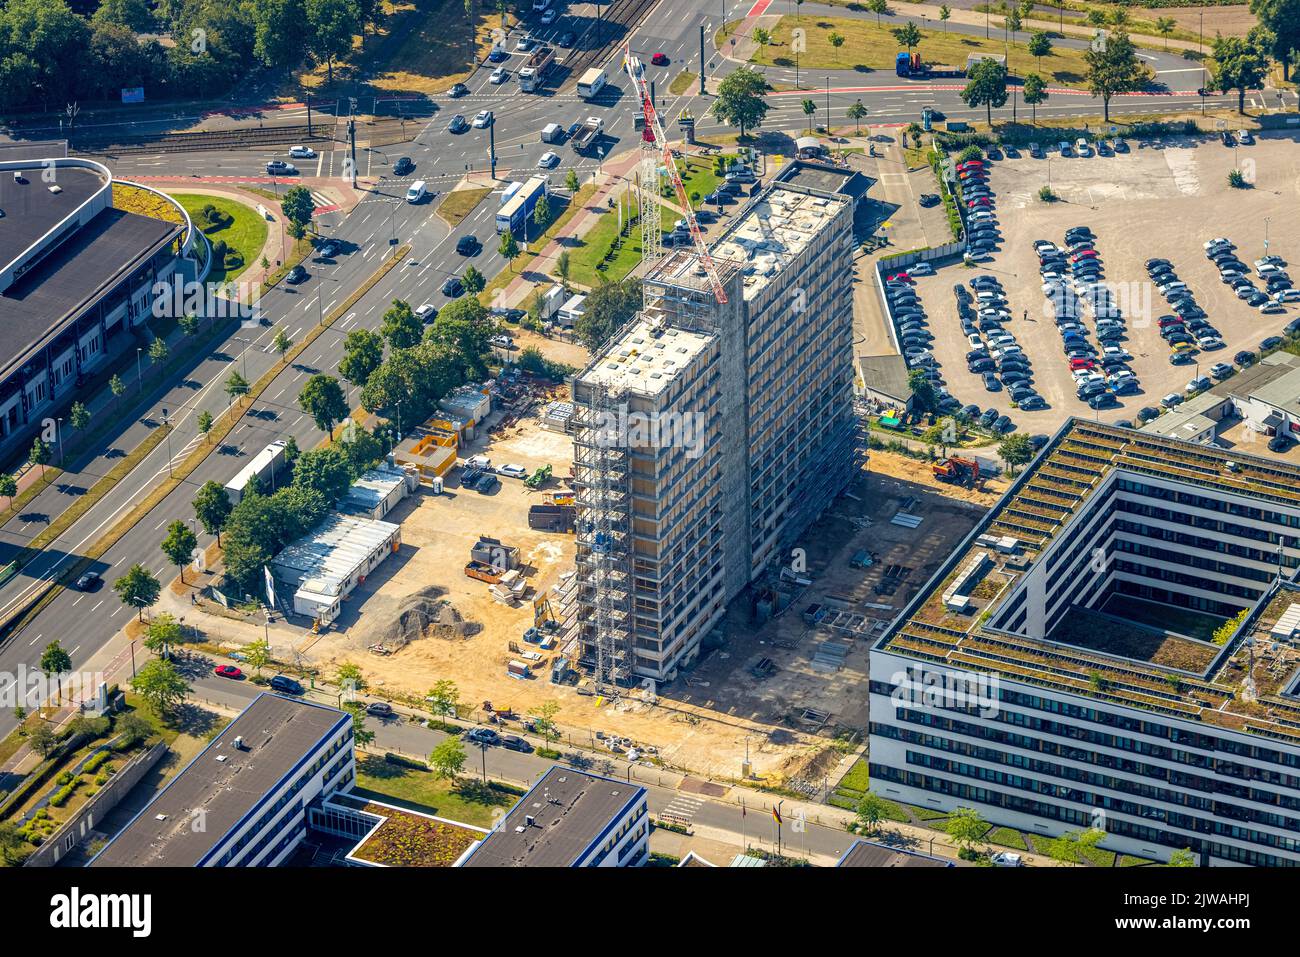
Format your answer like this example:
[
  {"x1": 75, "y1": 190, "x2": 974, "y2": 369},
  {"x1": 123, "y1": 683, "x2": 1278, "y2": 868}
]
[{"x1": 91, "y1": 693, "x2": 356, "y2": 867}]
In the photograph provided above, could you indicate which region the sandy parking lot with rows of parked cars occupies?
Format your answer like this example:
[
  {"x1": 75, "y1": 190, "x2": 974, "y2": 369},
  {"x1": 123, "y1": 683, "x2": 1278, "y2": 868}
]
[{"x1": 917, "y1": 134, "x2": 1300, "y2": 433}]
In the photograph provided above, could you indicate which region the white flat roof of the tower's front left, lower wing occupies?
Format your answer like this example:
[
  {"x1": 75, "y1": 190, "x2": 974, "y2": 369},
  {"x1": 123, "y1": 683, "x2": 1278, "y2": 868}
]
[{"x1": 579, "y1": 312, "x2": 718, "y2": 395}]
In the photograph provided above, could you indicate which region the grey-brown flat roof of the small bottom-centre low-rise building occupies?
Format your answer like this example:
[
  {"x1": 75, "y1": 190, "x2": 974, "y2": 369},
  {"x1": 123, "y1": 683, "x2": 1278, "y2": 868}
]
[{"x1": 464, "y1": 766, "x2": 646, "y2": 867}]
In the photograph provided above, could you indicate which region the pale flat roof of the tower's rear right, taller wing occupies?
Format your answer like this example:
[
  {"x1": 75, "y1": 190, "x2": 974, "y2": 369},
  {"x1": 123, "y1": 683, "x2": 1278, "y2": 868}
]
[{"x1": 710, "y1": 181, "x2": 850, "y2": 299}]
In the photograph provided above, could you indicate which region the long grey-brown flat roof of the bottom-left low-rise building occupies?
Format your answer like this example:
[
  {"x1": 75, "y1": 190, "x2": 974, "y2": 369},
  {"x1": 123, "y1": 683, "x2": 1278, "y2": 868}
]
[{"x1": 91, "y1": 692, "x2": 352, "y2": 867}]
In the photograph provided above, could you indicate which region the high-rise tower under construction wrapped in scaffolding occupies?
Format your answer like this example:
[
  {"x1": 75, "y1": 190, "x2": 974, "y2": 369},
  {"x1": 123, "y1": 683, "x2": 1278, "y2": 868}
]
[{"x1": 573, "y1": 164, "x2": 858, "y2": 688}]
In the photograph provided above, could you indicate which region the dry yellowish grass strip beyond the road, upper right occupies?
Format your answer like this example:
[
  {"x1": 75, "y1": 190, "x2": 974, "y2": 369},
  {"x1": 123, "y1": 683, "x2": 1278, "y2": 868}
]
[{"x1": 753, "y1": 17, "x2": 1102, "y2": 89}]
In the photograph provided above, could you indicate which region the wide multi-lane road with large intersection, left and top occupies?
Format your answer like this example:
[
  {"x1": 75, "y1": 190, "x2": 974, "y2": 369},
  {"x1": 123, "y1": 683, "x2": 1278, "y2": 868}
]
[{"x1": 0, "y1": 0, "x2": 1271, "y2": 732}]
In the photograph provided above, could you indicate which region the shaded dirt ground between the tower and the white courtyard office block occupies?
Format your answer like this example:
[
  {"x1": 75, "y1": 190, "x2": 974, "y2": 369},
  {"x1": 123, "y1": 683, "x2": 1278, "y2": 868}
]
[{"x1": 662, "y1": 454, "x2": 993, "y2": 784}]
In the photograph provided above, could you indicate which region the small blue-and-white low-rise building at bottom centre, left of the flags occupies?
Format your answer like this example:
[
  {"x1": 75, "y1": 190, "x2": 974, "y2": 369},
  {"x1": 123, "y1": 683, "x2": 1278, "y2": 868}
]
[{"x1": 462, "y1": 766, "x2": 650, "y2": 867}]
